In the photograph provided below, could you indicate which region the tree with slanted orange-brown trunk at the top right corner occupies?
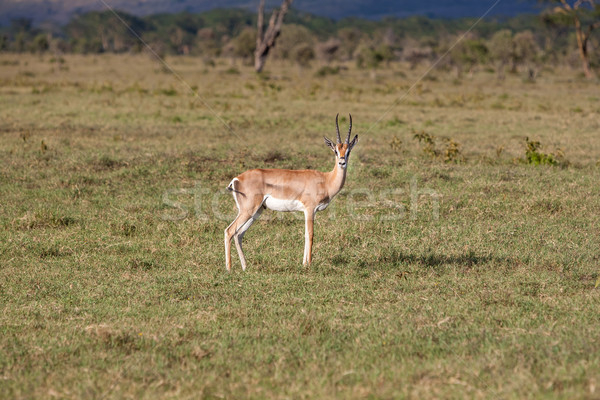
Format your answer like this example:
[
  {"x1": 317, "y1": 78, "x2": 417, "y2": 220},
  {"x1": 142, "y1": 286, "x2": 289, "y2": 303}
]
[{"x1": 544, "y1": 0, "x2": 600, "y2": 78}]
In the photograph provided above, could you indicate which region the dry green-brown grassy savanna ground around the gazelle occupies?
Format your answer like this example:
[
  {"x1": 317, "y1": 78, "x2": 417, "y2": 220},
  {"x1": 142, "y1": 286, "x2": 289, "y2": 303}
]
[{"x1": 0, "y1": 54, "x2": 600, "y2": 399}]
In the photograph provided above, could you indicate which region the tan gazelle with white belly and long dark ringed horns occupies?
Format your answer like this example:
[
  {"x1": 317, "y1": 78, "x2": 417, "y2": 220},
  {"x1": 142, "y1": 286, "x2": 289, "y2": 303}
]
[{"x1": 225, "y1": 114, "x2": 358, "y2": 271}]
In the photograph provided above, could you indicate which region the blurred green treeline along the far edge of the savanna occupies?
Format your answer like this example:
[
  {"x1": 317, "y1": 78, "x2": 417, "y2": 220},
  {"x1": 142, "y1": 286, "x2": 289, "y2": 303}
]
[{"x1": 0, "y1": 9, "x2": 600, "y2": 74}]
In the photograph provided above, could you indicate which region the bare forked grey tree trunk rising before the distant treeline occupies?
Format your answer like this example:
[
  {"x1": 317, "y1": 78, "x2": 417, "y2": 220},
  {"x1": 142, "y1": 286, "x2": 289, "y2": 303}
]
[{"x1": 254, "y1": 0, "x2": 293, "y2": 72}]
